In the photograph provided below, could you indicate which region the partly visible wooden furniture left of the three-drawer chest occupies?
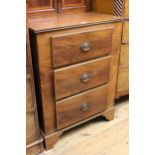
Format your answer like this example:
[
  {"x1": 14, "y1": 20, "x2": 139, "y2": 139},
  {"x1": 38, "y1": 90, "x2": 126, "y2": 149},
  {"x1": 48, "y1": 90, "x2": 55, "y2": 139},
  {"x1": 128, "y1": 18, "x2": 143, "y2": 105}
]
[{"x1": 26, "y1": 0, "x2": 43, "y2": 155}]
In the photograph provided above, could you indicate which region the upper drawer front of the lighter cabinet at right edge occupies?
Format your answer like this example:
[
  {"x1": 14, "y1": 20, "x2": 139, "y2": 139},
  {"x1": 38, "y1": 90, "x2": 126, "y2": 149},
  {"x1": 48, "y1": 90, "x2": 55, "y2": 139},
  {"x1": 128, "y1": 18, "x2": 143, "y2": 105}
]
[{"x1": 122, "y1": 21, "x2": 129, "y2": 43}]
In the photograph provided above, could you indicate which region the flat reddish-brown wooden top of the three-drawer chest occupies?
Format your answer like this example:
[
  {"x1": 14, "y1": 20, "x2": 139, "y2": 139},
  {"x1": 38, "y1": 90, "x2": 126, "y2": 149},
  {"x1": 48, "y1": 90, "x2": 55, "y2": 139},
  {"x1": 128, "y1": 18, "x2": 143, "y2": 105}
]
[{"x1": 28, "y1": 12, "x2": 122, "y2": 33}]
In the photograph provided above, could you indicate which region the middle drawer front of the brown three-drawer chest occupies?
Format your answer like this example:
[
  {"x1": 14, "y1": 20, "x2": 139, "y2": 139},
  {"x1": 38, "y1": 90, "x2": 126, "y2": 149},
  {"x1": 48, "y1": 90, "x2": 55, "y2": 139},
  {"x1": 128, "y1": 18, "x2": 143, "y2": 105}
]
[{"x1": 54, "y1": 57, "x2": 110, "y2": 100}]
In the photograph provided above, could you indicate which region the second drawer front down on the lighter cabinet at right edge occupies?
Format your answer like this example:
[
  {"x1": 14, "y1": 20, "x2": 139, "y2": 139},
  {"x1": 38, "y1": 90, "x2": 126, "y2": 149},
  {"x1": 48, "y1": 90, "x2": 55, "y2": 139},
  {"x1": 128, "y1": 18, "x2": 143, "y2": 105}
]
[{"x1": 120, "y1": 44, "x2": 129, "y2": 67}]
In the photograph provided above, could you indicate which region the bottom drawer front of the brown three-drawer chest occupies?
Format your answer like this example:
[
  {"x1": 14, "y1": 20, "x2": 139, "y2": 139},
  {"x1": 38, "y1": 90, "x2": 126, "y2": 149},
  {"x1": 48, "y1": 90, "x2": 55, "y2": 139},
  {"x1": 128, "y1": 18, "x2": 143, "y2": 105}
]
[{"x1": 56, "y1": 85, "x2": 108, "y2": 129}]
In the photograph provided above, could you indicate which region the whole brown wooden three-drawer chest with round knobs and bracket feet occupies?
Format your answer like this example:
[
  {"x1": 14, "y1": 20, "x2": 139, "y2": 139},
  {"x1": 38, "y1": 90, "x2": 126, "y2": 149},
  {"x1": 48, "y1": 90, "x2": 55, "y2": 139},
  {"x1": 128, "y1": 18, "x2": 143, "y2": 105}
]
[{"x1": 29, "y1": 12, "x2": 122, "y2": 149}]
